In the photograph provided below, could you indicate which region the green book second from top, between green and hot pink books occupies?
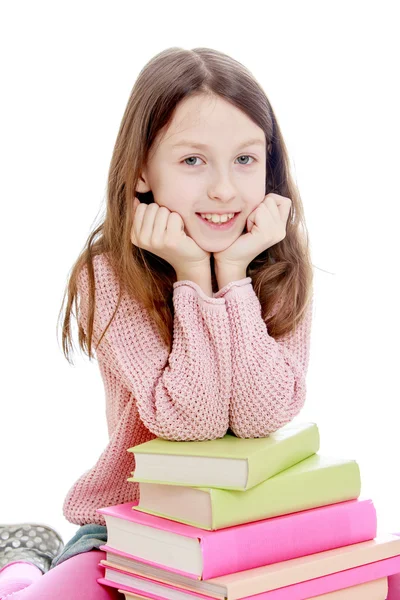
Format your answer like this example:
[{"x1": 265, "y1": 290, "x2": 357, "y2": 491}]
[{"x1": 133, "y1": 454, "x2": 361, "y2": 533}]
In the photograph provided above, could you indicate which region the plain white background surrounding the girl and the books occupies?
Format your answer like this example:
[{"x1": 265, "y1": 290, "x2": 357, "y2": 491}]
[{"x1": 0, "y1": 0, "x2": 400, "y2": 542}]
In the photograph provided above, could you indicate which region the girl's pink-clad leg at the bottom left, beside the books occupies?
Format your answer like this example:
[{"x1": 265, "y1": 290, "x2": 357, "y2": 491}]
[{"x1": 3, "y1": 550, "x2": 125, "y2": 600}]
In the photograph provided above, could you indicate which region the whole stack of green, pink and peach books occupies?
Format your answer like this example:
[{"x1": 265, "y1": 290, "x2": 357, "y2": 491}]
[{"x1": 97, "y1": 423, "x2": 400, "y2": 600}]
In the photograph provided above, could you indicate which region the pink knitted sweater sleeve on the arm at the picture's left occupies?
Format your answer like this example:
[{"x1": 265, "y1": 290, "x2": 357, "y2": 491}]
[{"x1": 78, "y1": 254, "x2": 232, "y2": 441}]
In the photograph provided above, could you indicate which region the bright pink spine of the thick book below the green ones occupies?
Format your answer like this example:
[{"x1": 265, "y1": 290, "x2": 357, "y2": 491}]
[{"x1": 200, "y1": 500, "x2": 377, "y2": 579}]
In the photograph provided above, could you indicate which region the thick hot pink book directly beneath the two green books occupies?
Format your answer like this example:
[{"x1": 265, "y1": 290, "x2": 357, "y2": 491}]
[{"x1": 97, "y1": 499, "x2": 377, "y2": 580}]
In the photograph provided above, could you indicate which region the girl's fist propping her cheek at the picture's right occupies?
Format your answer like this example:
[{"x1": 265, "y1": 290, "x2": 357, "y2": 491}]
[{"x1": 213, "y1": 193, "x2": 292, "y2": 269}]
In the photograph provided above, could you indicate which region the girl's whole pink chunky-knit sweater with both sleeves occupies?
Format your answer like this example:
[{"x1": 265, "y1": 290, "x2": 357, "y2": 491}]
[{"x1": 63, "y1": 254, "x2": 313, "y2": 525}]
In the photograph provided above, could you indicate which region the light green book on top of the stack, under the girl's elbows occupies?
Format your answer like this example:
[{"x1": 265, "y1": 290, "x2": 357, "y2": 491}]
[{"x1": 127, "y1": 423, "x2": 320, "y2": 490}]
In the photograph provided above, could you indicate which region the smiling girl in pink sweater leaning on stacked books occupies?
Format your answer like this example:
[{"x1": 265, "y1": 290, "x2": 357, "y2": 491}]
[{"x1": 0, "y1": 47, "x2": 313, "y2": 600}]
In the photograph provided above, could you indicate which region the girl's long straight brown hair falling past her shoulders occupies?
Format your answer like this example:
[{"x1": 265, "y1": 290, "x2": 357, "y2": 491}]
[{"x1": 59, "y1": 47, "x2": 313, "y2": 362}]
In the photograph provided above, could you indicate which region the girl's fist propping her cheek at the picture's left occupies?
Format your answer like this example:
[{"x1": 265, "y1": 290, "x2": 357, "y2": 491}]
[{"x1": 131, "y1": 198, "x2": 211, "y2": 273}]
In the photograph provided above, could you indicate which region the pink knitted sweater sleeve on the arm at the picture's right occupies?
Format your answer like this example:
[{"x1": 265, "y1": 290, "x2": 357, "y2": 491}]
[{"x1": 213, "y1": 277, "x2": 313, "y2": 438}]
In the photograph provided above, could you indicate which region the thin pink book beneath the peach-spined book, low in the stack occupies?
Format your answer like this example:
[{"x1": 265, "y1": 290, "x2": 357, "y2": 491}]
[{"x1": 97, "y1": 555, "x2": 400, "y2": 600}]
